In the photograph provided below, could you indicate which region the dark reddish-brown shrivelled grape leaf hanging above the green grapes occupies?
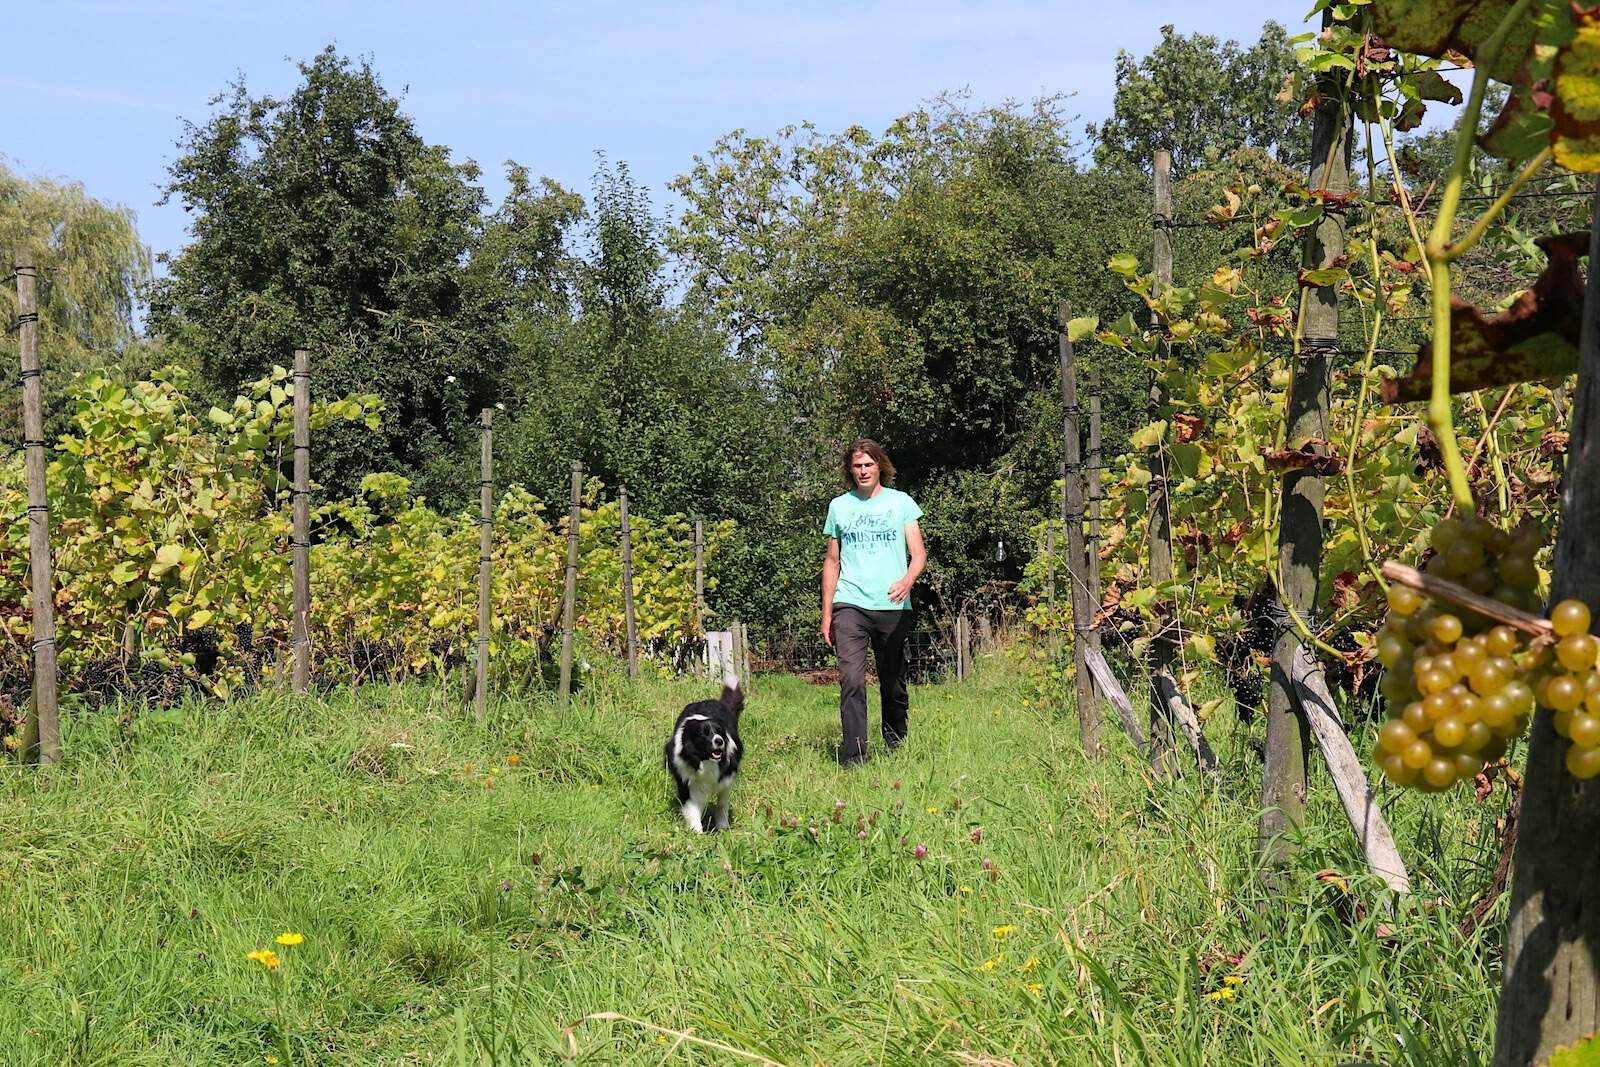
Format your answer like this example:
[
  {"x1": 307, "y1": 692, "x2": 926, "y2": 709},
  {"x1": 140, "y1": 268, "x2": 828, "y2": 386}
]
[{"x1": 1382, "y1": 234, "x2": 1589, "y2": 403}]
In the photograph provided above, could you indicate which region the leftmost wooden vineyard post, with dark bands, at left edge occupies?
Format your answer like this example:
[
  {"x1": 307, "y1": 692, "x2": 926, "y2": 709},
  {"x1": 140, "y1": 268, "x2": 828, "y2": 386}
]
[{"x1": 16, "y1": 248, "x2": 61, "y2": 766}]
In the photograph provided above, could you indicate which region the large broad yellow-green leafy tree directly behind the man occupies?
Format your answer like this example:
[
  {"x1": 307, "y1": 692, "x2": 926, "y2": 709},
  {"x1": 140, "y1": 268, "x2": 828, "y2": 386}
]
[{"x1": 669, "y1": 98, "x2": 1149, "y2": 607}]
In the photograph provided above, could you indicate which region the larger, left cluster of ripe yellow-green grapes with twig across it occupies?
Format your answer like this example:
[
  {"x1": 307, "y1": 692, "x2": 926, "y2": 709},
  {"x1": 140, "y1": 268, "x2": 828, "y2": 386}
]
[{"x1": 1373, "y1": 515, "x2": 1542, "y2": 792}]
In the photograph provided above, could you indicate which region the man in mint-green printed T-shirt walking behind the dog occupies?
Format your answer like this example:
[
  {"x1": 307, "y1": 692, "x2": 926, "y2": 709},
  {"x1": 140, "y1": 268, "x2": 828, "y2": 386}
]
[{"x1": 822, "y1": 438, "x2": 928, "y2": 766}]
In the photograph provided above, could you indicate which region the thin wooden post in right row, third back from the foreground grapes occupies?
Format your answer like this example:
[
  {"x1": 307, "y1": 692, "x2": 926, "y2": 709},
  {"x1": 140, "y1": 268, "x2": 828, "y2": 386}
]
[{"x1": 1146, "y1": 149, "x2": 1178, "y2": 771}]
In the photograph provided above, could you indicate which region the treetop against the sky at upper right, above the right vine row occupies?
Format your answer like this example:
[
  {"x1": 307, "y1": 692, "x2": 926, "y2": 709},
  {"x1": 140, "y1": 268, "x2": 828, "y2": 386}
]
[{"x1": 1088, "y1": 22, "x2": 1310, "y2": 178}]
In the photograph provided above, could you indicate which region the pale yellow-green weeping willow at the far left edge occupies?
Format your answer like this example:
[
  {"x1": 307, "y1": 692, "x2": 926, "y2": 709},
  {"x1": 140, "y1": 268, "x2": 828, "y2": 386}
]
[{"x1": 0, "y1": 165, "x2": 150, "y2": 450}]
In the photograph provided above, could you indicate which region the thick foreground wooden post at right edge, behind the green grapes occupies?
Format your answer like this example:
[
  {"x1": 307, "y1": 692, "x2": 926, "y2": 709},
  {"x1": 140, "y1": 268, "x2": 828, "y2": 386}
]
[{"x1": 1494, "y1": 184, "x2": 1600, "y2": 1067}]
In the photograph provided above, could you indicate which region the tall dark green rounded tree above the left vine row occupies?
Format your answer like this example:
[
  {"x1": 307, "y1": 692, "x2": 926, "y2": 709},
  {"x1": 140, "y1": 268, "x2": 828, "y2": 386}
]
[{"x1": 150, "y1": 46, "x2": 498, "y2": 493}]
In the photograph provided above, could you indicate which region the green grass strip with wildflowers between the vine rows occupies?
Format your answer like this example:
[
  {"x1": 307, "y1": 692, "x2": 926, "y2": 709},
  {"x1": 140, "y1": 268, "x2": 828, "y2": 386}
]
[{"x1": 0, "y1": 661, "x2": 1504, "y2": 1067}]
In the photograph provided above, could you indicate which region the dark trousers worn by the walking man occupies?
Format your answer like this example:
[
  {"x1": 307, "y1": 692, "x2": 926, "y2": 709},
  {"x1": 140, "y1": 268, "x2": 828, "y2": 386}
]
[{"x1": 834, "y1": 605, "x2": 910, "y2": 760}]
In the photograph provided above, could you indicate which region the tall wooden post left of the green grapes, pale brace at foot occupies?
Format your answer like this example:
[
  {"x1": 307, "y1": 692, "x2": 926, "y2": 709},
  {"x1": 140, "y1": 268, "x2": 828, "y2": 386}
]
[{"x1": 1258, "y1": 35, "x2": 1350, "y2": 880}]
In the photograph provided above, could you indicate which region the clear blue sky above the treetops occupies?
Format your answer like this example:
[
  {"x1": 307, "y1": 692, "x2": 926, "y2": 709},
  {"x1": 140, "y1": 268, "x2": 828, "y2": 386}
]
[{"x1": 0, "y1": 0, "x2": 1310, "y2": 262}]
